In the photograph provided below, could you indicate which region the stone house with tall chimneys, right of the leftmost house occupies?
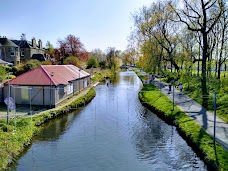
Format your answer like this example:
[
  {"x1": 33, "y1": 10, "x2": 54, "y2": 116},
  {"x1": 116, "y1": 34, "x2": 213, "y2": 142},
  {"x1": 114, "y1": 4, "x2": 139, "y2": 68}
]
[{"x1": 12, "y1": 38, "x2": 45, "y2": 61}]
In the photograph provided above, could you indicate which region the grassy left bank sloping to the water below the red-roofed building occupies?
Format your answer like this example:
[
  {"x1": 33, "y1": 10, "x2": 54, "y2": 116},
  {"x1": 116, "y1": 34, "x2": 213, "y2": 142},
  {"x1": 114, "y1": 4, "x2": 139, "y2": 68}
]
[{"x1": 0, "y1": 88, "x2": 96, "y2": 170}]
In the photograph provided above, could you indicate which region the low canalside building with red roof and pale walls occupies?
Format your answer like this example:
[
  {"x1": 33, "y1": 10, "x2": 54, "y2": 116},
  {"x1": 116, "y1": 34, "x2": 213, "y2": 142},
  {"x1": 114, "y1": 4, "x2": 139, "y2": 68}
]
[{"x1": 4, "y1": 65, "x2": 90, "y2": 107}]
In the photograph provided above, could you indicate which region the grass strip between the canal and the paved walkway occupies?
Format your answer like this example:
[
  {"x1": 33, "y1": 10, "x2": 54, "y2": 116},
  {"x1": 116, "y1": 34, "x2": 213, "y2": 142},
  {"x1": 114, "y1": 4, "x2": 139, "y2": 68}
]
[{"x1": 136, "y1": 72, "x2": 228, "y2": 170}]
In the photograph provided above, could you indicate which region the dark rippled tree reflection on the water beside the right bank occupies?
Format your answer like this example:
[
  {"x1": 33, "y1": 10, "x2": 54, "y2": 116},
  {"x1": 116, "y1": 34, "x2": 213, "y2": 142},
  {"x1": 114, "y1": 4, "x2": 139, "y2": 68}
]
[{"x1": 132, "y1": 108, "x2": 207, "y2": 170}]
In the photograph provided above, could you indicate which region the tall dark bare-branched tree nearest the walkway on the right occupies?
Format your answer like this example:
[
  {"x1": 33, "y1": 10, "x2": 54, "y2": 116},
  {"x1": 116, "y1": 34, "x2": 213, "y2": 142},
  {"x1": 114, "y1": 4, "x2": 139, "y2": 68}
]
[{"x1": 170, "y1": 0, "x2": 223, "y2": 107}]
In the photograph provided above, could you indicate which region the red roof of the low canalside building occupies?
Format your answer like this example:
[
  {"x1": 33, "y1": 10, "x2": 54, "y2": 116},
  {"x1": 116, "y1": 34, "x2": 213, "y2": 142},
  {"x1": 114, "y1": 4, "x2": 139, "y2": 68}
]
[{"x1": 10, "y1": 65, "x2": 90, "y2": 86}]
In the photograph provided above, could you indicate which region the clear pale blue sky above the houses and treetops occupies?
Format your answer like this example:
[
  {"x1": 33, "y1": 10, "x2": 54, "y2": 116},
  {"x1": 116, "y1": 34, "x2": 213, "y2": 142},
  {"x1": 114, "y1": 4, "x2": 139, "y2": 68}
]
[{"x1": 0, "y1": 0, "x2": 152, "y2": 51}]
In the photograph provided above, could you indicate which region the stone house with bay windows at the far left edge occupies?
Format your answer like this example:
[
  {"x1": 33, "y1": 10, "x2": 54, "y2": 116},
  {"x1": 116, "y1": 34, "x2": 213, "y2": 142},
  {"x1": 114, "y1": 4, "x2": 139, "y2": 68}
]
[{"x1": 0, "y1": 37, "x2": 20, "y2": 65}]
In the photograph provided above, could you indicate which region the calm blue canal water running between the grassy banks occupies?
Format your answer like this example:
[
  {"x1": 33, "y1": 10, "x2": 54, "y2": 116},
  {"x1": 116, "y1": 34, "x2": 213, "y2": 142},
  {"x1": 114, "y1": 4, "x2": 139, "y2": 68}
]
[{"x1": 11, "y1": 71, "x2": 207, "y2": 171}]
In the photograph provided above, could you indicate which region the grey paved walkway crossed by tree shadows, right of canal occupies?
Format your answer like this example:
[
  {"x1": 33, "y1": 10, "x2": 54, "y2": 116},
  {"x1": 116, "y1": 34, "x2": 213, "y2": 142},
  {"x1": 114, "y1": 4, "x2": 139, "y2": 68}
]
[{"x1": 136, "y1": 69, "x2": 228, "y2": 151}]
